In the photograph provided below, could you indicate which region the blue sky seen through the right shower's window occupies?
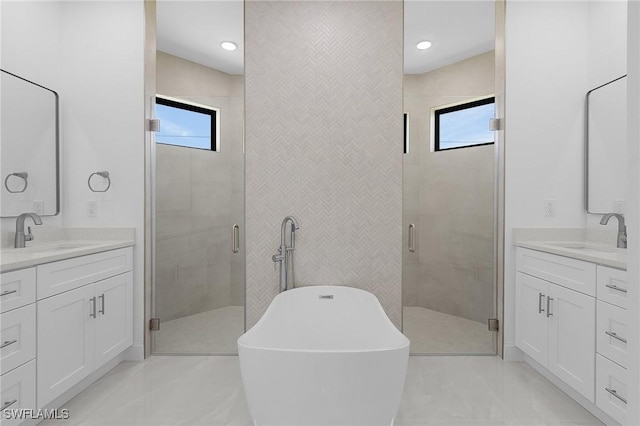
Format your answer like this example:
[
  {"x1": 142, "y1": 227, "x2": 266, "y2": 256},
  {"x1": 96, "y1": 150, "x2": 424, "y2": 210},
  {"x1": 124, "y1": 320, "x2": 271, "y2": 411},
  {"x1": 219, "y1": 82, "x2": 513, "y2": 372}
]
[{"x1": 439, "y1": 103, "x2": 495, "y2": 149}]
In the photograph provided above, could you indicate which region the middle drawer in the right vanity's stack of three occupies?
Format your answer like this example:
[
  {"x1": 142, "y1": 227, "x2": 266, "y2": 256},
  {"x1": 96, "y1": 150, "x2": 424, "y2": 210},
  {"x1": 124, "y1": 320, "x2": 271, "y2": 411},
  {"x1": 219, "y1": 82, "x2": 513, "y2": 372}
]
[{"x1": 597, "y1": 300, "x2": 629, "y2": 368}]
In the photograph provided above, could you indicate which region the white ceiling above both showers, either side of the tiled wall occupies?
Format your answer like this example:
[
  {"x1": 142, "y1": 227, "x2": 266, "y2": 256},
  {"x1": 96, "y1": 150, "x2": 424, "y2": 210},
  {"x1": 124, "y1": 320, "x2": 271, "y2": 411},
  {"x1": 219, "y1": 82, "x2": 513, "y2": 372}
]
[{"x1": 157, "y1": 0, "x2": 494, "y2": 74}]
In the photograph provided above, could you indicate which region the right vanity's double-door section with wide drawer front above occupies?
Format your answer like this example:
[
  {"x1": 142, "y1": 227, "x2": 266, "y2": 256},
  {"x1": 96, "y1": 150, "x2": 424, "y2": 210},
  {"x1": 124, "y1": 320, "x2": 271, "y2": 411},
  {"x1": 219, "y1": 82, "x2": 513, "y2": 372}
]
[{"x1": 516, "y1": 248, "x2": 596, "y2": 402}]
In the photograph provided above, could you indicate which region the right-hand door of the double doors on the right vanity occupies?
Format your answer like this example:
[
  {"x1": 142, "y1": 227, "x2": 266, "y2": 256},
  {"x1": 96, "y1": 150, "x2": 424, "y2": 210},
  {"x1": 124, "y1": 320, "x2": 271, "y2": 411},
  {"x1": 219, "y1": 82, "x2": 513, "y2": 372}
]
[{"x1": 548, "y1": 284, "x2": 596, "y2": 402}]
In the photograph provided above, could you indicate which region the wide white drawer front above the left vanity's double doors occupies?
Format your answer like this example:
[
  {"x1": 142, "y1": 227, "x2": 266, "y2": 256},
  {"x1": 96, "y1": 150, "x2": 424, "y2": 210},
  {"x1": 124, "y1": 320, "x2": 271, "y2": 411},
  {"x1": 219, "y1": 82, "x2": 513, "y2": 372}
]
[{"x1": 37, "y1": 247, "x2": 133, "y2": 300}]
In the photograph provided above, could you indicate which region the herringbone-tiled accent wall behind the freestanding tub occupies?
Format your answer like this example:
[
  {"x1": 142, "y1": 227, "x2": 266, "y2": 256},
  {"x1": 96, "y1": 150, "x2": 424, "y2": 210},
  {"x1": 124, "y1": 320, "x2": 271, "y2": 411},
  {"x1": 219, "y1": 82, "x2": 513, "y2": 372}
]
[{"x1": 245, "y1": 1, "x2": 403, "y2": 327}]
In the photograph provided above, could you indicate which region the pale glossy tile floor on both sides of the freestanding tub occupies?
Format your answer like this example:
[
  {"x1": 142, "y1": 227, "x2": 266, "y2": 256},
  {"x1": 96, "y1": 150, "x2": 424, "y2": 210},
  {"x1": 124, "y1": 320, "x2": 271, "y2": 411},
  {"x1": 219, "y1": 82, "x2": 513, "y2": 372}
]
[{"x1": 41, "y1": 356, "x2": 601, "y2": 426}]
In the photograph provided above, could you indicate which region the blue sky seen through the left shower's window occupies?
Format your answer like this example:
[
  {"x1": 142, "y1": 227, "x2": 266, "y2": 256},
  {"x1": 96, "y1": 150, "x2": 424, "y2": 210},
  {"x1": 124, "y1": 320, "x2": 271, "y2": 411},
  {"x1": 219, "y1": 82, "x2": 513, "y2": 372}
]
[{"x1": 156, "y1": 103, "x2": 213, "y2": 150}]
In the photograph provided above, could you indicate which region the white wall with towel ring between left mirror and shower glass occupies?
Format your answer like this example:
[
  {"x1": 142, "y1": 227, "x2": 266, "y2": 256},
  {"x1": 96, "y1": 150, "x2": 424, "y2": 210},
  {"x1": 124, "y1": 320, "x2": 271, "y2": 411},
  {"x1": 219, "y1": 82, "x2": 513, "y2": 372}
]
[{"x1": 59, "y1": 1, "x2": 144, "y2": 357}]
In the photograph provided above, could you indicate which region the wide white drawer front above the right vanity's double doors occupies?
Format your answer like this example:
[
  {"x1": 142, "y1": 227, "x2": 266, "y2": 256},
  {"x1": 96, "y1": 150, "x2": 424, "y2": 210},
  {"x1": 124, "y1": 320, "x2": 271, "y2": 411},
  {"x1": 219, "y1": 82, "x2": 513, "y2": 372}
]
[{"x1": 517, "y1": 248, "x2": 596, "y2": 296}]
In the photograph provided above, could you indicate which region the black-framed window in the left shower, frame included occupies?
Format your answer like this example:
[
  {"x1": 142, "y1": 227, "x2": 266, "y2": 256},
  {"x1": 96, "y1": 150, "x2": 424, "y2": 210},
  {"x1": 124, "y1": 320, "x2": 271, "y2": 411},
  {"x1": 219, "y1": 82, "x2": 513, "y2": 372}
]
[{"x1": 156, "y1": 96, "x2": 219, "y2": 151}]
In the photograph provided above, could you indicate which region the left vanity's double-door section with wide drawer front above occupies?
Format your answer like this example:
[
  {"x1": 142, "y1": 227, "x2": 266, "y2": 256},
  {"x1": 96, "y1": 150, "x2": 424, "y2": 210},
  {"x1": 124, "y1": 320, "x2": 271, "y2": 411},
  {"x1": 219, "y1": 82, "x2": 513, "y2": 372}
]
[{"x1": 37, "y1": 248, "x2": 133, "y2": 408}]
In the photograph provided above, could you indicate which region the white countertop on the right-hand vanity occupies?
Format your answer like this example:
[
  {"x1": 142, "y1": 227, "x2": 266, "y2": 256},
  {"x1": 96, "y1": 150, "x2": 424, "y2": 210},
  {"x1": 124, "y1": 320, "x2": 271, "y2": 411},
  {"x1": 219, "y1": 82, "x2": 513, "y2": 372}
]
[{"x1": 514, "y1": 241, "x2": 627, "y2": 270}]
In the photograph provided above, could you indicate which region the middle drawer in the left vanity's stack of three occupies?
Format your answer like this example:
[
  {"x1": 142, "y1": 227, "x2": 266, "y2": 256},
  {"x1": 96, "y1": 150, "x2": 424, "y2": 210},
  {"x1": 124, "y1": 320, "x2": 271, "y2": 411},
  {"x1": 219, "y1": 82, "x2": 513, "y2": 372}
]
[{"x1": 0, "y1": 303, "x2": 36, "y2": 374}]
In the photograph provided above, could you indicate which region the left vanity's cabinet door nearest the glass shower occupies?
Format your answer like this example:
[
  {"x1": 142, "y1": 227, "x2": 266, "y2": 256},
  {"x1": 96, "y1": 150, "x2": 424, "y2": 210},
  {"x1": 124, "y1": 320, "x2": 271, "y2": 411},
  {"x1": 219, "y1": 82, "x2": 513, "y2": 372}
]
[{"x1": 95, "y1": 272, "x2": 133, "y2": 368}]
